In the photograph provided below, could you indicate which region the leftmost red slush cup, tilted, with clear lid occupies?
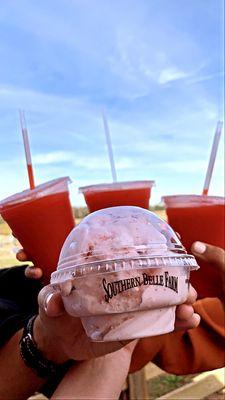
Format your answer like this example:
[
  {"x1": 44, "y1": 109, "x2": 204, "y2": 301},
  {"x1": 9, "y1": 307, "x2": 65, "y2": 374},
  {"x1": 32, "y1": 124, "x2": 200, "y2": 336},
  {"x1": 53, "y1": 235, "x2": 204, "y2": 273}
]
[{"x1": 0, "y1": 177, "x2": 75, "y2": 282}]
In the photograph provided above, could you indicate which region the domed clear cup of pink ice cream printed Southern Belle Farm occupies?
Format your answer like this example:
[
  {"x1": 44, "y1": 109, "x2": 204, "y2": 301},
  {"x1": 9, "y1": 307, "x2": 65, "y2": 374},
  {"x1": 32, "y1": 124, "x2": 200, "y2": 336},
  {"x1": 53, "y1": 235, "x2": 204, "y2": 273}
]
[{"x1": 51, "y1": 206, "x2": 198, "y2": 341}]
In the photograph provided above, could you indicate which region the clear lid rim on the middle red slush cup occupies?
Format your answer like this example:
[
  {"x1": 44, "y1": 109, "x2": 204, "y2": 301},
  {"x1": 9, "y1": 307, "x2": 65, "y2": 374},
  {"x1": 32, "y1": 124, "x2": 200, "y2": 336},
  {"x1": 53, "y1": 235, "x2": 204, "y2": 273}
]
[{"x1": 79, "y1": 180, "x2": 155, "y2": 193}]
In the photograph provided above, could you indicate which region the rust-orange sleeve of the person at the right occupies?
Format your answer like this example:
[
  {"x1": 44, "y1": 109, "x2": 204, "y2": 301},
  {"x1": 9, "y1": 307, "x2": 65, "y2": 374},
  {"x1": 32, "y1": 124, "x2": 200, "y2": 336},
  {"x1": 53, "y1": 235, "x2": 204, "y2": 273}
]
[{"x1": 130, "y1": 298, "x2": 225, "y2": 375}]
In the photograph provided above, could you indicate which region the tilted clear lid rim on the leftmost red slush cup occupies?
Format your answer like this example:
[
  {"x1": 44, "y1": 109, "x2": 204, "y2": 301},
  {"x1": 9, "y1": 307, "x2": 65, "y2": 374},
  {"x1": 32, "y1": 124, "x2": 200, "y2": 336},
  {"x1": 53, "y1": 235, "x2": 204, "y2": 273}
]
[{"x1": 0, "y1": 176, "x2": 72, "y2": 210}]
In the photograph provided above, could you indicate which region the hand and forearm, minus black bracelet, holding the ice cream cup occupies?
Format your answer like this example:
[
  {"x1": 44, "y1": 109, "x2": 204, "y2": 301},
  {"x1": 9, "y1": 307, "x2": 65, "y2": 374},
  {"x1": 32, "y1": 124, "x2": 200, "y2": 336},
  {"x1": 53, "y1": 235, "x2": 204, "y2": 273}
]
[{"x1": 0, "y1": 287, "x2": 131, "y2": 400}]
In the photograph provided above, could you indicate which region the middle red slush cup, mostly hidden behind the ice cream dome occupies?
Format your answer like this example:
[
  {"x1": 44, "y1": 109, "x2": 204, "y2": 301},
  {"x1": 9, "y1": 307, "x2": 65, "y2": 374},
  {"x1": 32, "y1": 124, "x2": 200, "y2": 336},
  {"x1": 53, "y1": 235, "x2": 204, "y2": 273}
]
[{"x1": 79, "y1": 181, "x2": 155, "y2": 212}]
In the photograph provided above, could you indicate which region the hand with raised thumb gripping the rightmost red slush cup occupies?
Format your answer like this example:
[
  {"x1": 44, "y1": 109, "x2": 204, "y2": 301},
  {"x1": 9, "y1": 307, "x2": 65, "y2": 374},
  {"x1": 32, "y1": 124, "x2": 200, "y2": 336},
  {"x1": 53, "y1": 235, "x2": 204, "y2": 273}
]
[{"x1": 191, "y1": 242, "x2": 225, "y2": 302}]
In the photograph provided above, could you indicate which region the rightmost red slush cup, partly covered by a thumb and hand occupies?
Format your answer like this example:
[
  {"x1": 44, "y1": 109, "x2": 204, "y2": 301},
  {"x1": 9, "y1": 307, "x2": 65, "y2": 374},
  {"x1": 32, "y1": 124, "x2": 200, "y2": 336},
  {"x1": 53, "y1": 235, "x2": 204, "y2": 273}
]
[{"x1": 163, "y1": 195, "x2": 225, "y2": 298}]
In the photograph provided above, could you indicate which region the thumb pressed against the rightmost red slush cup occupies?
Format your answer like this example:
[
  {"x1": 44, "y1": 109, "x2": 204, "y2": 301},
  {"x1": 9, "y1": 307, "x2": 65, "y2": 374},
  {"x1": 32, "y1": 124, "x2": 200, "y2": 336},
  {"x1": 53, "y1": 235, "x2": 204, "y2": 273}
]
[{"x1": 191, "y1": 242, "x2": 225, "y2": 271}]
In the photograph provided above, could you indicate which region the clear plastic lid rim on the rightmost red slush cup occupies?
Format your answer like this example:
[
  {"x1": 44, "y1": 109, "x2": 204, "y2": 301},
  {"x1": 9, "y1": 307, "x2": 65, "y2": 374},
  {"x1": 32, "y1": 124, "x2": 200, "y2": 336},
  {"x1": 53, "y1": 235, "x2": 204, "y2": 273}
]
[{"x1": 161, "y1": 194, "x2": 225, "y2": 208}]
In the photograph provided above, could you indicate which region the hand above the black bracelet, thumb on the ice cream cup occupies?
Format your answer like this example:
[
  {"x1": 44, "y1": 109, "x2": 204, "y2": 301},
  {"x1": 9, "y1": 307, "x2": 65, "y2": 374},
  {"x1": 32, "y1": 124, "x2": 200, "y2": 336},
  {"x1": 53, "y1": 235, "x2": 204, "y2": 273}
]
[{"x1": 34, "y1": 285, "x2": 129, "y2": 363}]
